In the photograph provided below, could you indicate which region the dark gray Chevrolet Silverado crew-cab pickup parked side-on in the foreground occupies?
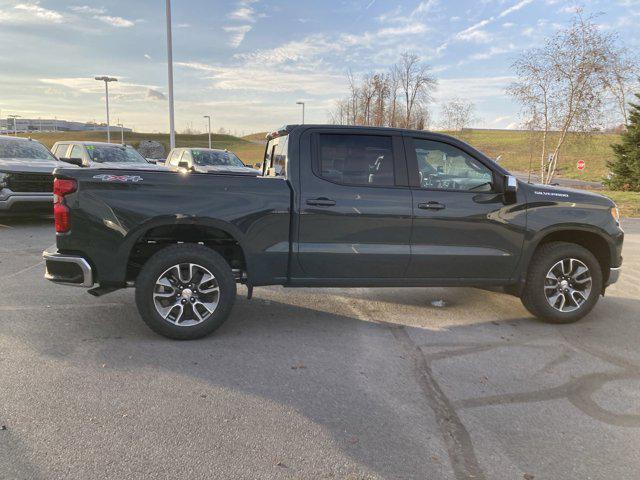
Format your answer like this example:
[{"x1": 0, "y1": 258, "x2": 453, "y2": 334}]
[{"x1": 44, "y1": 125, "x2": 623, "y2": 339}]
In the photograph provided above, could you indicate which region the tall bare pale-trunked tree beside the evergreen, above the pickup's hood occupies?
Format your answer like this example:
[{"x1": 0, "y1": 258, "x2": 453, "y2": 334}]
[{"x1": 508, "y1": 11, "x2": 615, "y2": 184}]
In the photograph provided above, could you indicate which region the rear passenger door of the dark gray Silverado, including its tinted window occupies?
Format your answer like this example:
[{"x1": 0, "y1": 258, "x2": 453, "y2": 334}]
[{"x1": 298, "y1": 129, "x2": 411, "y2": 279}]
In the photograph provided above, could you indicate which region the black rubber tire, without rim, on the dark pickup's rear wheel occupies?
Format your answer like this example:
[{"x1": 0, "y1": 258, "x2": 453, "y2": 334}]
[{"x1": 136, "y1": 244, "x2": 236, "y2": 340}]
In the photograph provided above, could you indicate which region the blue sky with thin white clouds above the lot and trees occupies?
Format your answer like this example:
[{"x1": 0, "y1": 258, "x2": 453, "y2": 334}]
[{"x1": 0, "y1": 0, "x2": 640, "y2": 134}]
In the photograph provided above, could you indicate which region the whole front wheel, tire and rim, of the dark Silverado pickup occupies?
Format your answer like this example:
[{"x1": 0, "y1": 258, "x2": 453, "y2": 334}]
[{"x1": 521, "y1": 242, "x2": 602, "y2": 323}]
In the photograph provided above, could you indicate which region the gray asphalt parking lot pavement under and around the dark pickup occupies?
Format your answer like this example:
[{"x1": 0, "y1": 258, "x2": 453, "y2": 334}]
[{"x1": 0, "y1": 220, "x2": 640, "y2": 480}]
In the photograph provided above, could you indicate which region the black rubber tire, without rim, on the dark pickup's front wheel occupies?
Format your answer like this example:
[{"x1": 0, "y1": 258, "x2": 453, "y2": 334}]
[{"x1": 520, "y1": 242, "x2": 602, "y2": 323}]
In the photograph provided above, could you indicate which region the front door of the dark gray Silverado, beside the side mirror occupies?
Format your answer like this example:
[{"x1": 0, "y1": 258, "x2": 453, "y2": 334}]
[{"x1": 405, "y1": 137, "x2": 524, "y2": 280}]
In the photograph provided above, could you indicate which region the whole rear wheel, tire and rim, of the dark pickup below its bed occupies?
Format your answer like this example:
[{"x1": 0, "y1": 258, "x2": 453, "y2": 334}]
[{"x1": 136, "y1": 244, "x2": 236, "y2": 340}]
